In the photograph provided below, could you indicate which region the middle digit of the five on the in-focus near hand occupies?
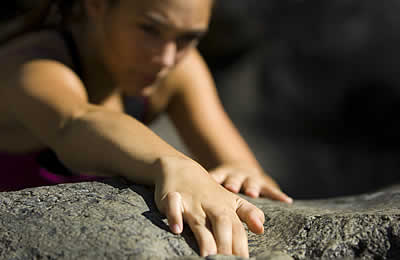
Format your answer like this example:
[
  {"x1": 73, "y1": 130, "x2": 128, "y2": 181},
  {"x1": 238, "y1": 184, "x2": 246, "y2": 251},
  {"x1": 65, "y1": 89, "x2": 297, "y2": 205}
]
[{"x1": 210, "y1": 214, "x2": 232, "y2": 255}]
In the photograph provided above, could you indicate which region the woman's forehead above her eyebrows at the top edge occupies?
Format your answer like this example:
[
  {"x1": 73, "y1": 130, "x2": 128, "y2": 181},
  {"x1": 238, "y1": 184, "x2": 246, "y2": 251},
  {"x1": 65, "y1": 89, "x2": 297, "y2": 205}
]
[{"x1": 121, "y1": 0, "x2": 213, "y2": 29}]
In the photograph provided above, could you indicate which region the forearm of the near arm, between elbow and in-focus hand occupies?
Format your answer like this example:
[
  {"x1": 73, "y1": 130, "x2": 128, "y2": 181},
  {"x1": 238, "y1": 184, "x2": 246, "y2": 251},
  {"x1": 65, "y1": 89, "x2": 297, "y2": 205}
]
[{"x1": 54, "y1": 105, "x2": 188, "y2": 184}]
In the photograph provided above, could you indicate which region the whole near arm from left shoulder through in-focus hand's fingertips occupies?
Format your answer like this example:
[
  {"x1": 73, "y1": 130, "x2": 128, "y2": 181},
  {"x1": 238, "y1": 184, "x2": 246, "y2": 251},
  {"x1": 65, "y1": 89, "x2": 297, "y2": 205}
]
[{"x1": 0, "y1": 60, "x2": 264, "y2": 257}]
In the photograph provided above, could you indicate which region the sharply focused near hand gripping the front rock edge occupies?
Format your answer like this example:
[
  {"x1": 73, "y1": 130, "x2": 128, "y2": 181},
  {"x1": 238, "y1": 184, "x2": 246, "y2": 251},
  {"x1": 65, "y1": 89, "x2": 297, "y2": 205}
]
[{"x1": 155, "y1": 158, "x2": 264, "y2": 257}]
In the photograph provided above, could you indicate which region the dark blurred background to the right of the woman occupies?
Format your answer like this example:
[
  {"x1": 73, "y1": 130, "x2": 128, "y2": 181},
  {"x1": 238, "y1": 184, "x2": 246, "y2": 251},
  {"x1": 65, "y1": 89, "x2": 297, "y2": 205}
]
[{"x1": 152, "y1": 0, "x2": 400, "y2": 199}]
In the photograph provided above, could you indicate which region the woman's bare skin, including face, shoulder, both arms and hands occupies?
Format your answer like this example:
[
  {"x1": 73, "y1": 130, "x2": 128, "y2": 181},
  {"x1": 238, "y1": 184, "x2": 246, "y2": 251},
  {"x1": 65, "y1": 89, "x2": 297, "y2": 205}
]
[{"x1": 0, "y1": 0, "x2": 291, "y2": 257}]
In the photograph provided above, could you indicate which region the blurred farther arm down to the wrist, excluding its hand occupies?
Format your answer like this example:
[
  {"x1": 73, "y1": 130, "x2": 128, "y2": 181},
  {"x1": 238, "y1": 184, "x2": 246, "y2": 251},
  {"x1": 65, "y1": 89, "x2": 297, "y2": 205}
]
[{"x1": 167, "y1": 51, "x2": 260, "y2": 169}]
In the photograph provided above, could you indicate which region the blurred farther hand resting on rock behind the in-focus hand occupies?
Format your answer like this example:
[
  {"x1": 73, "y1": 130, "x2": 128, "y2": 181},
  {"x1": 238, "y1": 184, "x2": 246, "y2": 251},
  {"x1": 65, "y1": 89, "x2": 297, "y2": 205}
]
[{"x1": 210, "y1": 165, "x2": 293, "y2": 203}]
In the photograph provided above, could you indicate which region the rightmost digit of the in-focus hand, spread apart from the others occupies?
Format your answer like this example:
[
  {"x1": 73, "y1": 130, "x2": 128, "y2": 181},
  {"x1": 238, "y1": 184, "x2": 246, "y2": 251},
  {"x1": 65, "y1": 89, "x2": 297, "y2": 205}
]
[{"x1": 236, "y1": 199, "x2": 265, "y2": 234}]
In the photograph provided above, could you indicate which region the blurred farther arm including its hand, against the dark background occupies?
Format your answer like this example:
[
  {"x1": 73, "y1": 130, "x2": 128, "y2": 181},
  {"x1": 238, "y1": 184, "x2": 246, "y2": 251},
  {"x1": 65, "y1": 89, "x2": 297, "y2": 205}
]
[{"x1": 165, "y1": 48, "x2": 291, "y2": 203}]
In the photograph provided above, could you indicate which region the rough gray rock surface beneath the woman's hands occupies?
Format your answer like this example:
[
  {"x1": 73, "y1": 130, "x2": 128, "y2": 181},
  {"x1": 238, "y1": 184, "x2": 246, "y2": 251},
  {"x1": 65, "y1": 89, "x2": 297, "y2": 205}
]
[{"x1": 0, "y1": 180, "x2": 400, "y2": 260}]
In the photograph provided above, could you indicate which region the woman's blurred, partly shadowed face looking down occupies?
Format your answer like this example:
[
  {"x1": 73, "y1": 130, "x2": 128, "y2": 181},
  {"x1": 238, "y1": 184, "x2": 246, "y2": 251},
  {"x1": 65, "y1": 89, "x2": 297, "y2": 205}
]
[{"x1": 87, "y1": 0, "x2": 213, "y2": 95}]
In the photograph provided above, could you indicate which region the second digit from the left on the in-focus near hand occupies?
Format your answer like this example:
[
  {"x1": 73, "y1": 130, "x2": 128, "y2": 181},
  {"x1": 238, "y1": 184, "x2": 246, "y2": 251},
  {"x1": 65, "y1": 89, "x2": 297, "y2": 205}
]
[{"x1": 185, "y1": 213, "x2": 217, "y2": 257}]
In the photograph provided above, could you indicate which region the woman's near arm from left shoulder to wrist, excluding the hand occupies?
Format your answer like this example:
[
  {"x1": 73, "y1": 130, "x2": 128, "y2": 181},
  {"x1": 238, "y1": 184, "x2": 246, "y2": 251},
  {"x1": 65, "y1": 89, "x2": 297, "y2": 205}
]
[{"x1": 4, "y1": 61, "x2": 183, "y2": 184}]
